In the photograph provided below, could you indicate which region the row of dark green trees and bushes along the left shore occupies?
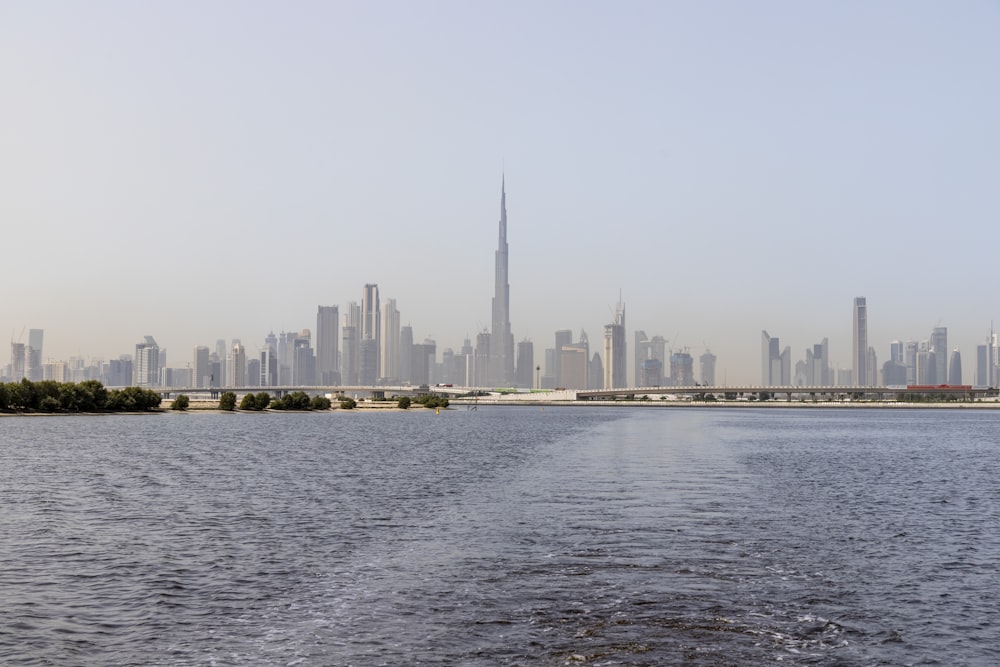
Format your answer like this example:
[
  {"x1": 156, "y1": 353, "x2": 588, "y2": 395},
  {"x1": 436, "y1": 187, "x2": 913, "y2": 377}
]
[{"x1": 0, "y1": 378, "x2": 448, "y2": 414}]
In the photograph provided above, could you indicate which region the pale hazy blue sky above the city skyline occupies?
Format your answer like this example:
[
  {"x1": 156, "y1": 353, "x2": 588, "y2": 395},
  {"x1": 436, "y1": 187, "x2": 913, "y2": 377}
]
[{"x1": 0, "y1": 0, "x2": 1000, "y2": 384}]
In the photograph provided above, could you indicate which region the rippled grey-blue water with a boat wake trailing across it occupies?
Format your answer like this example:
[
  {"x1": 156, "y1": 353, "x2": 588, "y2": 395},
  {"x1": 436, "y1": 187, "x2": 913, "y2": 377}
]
[{"x1": 0, "y1": 408, "x2": 1000, "y2": 666}]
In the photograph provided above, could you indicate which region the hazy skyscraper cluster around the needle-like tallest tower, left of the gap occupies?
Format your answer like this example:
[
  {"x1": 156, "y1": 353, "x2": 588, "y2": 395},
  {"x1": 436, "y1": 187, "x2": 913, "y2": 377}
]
[{"x1": 0, "y1": 182, "x2": 715, "y2": 389}]
